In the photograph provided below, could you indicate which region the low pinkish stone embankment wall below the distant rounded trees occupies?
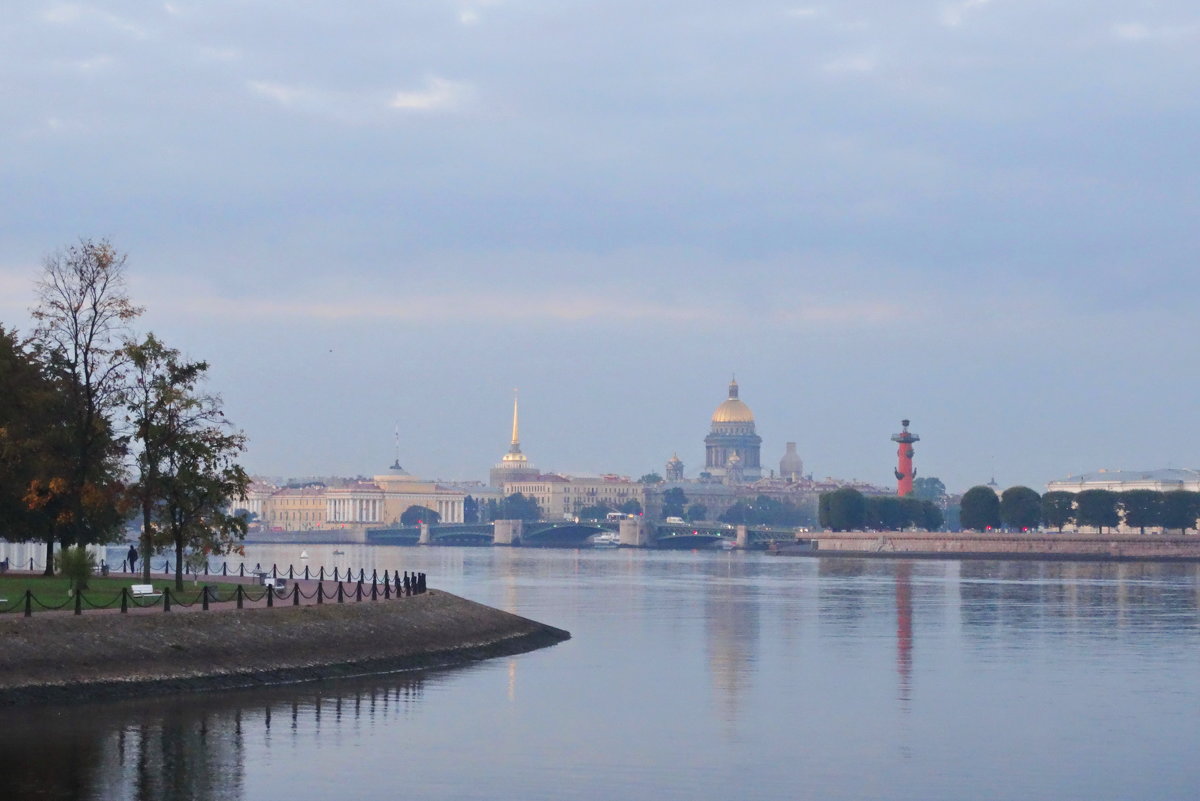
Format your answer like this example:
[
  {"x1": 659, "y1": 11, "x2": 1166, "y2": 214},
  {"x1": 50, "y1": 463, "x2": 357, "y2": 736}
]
[{"x1": 797, "y1": 531, "x2": 1200, "y2": 560}]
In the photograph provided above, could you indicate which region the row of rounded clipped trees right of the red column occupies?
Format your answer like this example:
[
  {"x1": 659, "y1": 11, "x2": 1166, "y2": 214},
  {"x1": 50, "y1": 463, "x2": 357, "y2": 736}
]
[{"x1": 960, "y1": 487, "x2": 1200, "y2": 534}]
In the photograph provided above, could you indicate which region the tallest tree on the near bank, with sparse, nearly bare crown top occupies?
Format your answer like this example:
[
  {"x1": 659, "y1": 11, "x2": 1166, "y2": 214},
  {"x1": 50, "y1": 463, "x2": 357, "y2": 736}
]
[{"x1": 32, "y1": 239, "x2": 142, "y2": 563}]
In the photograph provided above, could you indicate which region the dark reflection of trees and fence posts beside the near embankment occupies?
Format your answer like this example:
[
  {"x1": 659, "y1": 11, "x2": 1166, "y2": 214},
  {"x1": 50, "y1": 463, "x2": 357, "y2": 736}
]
[{"x1": 0, "y1": 674, "x2": 424, "y2": 801}]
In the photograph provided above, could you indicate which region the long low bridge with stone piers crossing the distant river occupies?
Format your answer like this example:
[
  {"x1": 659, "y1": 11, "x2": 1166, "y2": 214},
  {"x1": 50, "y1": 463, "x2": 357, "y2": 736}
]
[{"x1": 366, "y1": 519, "x2": 797, "y2": 550}]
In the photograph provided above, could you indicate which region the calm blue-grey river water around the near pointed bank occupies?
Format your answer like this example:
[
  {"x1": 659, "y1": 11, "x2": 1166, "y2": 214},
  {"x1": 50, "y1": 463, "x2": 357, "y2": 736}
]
[{"x1": 0, "y1": 546, "x2": 1200, "y2": 801}]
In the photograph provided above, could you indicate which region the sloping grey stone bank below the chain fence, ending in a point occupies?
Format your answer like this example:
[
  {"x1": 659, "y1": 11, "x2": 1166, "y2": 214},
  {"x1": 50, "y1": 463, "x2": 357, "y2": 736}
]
[{"x1": 0, "y1": 590, "x2": 570, "y2": 704}]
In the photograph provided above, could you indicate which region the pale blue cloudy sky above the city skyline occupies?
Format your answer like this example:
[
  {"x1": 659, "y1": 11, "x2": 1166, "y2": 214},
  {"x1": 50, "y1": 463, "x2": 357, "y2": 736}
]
[{"x1": 0, "y1": 0, "x2": 1200, "y2": 490}]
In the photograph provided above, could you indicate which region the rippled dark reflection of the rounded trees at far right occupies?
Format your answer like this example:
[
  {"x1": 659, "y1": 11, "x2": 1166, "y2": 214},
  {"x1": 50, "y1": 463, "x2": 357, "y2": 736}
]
[{"x1": 960, "y1": 560, "x2": 1200, "y2": 636}]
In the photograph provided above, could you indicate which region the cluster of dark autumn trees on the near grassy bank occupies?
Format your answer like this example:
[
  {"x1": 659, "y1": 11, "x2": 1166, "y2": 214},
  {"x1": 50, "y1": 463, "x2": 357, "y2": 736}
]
[{"x1": 0, "y1": 240, "x2": 250, "y2": 588}]
